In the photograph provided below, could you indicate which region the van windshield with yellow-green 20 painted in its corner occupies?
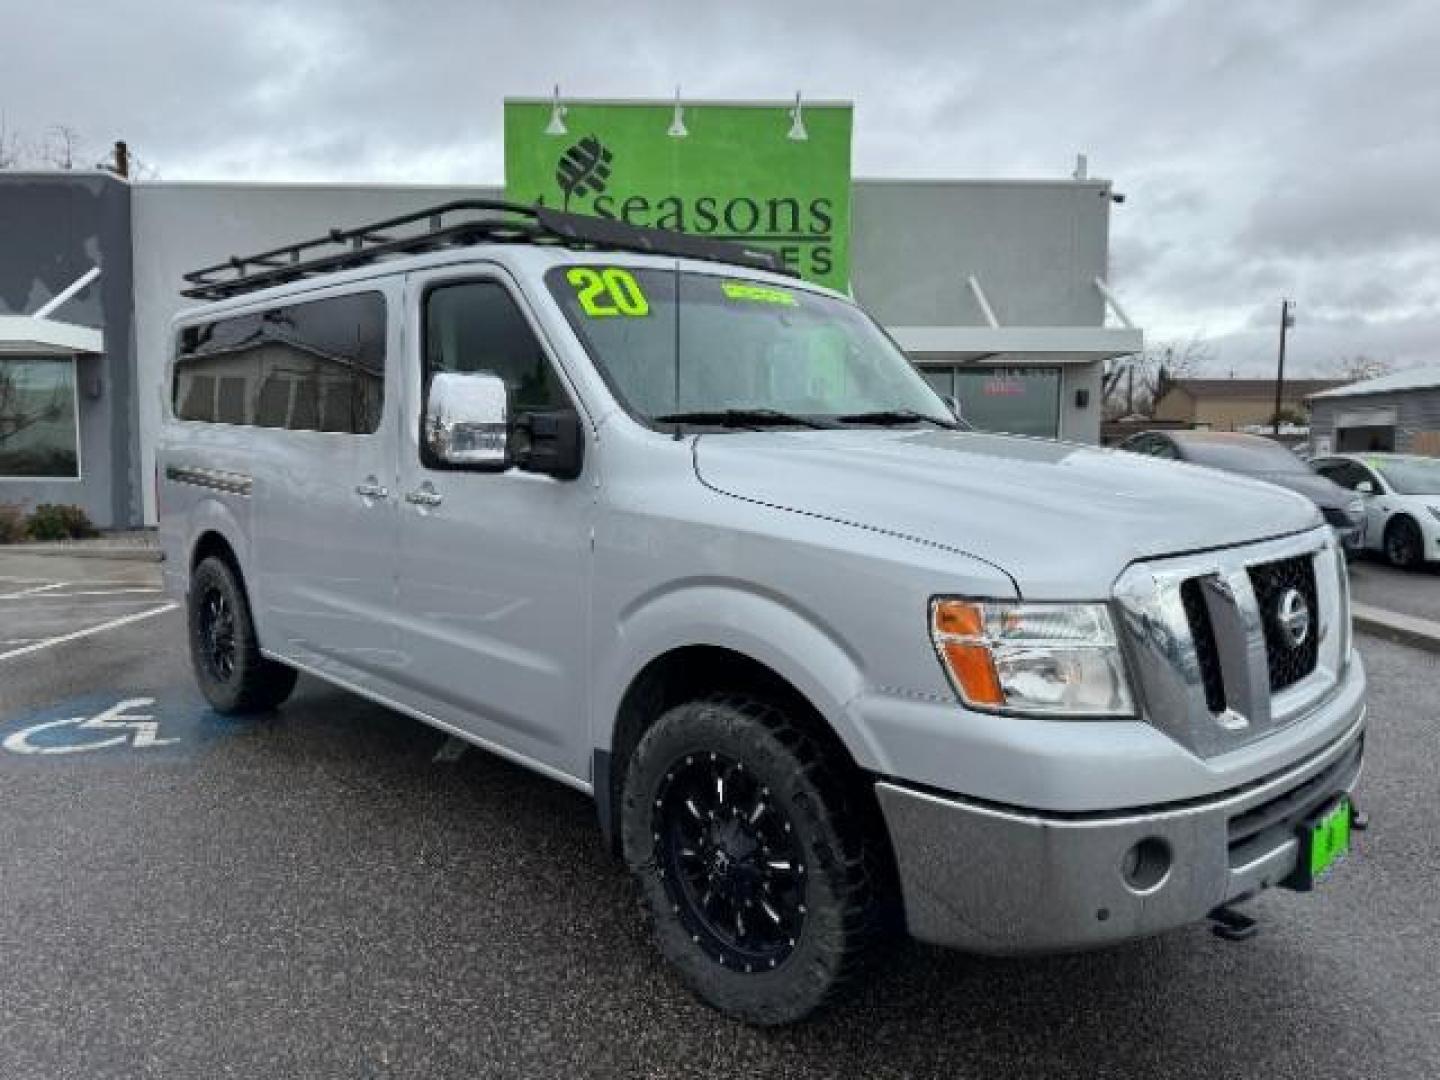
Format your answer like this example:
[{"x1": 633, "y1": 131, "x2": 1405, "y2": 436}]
[{"x1": 546, "y1": 265, "x2": 955, "y2": 428}]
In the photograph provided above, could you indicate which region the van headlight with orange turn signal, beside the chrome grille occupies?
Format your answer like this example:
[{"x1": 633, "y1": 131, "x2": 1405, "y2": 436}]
[{"x1": 930, "y1": 599, "x2": 1135, "y2": 716}]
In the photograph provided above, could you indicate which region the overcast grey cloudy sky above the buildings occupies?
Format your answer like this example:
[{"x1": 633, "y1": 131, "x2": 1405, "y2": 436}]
[{"x1": 0, "y1": 0, "x2": 1440, "y2": 374}]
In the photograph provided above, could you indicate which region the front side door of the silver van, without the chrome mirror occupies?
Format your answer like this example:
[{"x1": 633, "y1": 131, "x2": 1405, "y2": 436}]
[{"x1": 397, "y1": 268, "x2": 595, "y2": 778}]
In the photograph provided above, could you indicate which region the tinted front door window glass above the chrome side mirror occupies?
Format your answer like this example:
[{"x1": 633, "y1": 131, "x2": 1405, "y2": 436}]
[{"x1": 425, "y1": 281, "x2": 570, "y2": 413}]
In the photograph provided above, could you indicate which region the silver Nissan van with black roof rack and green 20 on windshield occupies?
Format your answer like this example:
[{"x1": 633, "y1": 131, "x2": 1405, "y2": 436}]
[{"x1": 158, "y1": 202, "x2": 1365, "y2": 1024}]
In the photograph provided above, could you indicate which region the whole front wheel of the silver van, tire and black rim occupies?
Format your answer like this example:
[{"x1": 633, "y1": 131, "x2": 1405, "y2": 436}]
[{"x1": 619, "y1": 691, "x2": 897, "y2": 1024}]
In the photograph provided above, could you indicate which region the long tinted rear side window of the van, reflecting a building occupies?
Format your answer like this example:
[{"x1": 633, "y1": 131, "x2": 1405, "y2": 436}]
[{"x1": 173, "y1": 292, "x2": 384, "y2": 435}]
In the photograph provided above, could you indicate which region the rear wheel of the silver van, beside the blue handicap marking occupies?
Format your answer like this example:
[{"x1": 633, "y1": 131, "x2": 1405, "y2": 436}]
[{"x1": 186, "y1": 556, "x2": 297, "y2": 716}]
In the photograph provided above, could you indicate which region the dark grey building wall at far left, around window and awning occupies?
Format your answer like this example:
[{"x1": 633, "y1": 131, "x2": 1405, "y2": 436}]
[{"x1": 0, "y1": 171, "x2": 143, "y2": 527}]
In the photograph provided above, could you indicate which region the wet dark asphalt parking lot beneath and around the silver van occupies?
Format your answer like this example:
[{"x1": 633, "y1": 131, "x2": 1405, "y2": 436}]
[{"x1": 0, "y1": 554, "x2": 1440, "y2": 1080}]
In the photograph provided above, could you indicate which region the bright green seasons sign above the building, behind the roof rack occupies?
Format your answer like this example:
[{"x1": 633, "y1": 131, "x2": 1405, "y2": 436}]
[{"x1": 505, "y1": 99, "x2": 851, "y2": 289}]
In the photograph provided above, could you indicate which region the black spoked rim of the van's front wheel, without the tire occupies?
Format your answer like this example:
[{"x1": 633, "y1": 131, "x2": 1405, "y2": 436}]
[{"x1": 652, "y1": 753, "x2": 805, "y2": 972}]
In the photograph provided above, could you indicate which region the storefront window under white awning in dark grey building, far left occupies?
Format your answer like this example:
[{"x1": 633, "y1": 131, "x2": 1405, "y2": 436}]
[{"x1": 0, "y1": 357, "x2": 81, "y2": 480}]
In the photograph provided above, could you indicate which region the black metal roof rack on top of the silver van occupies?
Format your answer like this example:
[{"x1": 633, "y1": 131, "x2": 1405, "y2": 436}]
[{"x1": 180, "y1": 199, "x2": 798, "y2": 300}]
